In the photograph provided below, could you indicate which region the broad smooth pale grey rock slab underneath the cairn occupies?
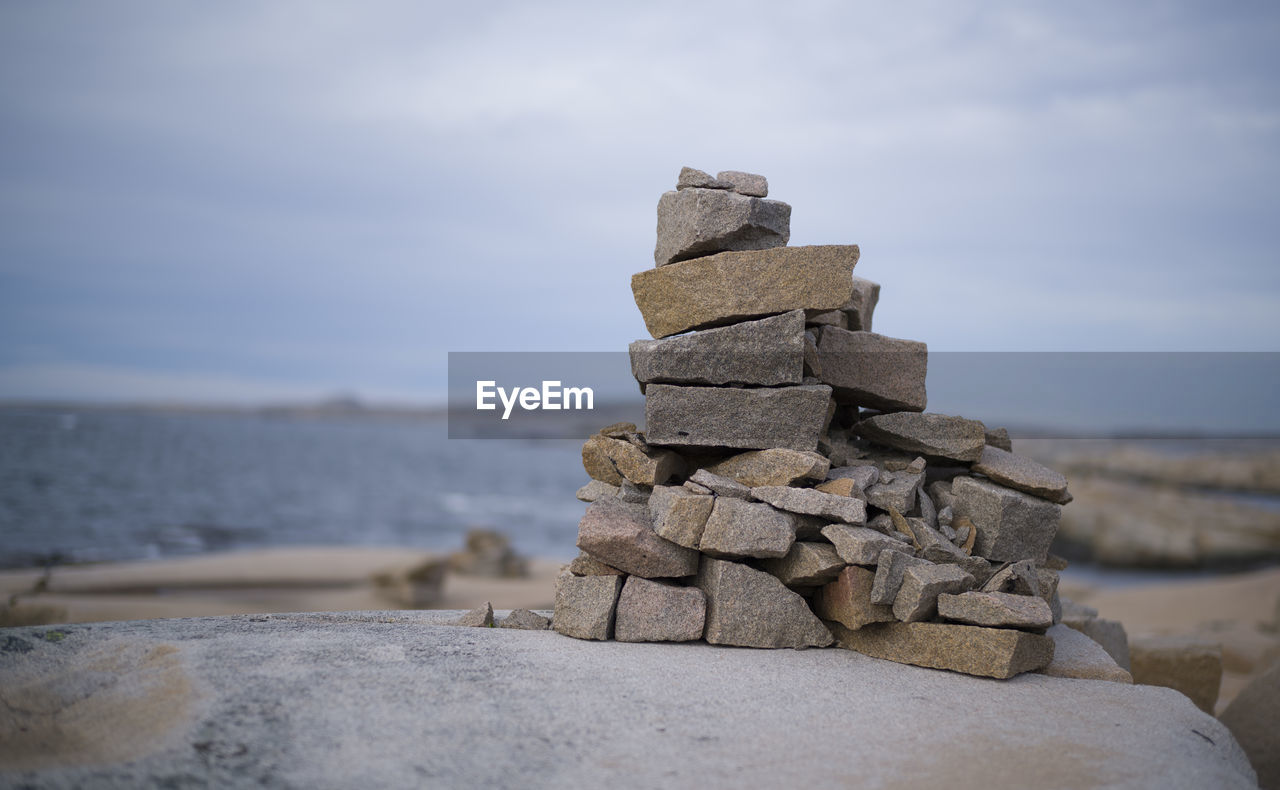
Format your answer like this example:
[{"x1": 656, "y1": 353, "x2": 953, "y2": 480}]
[{"x1": 0, "y1": 612, "x2": 1256, "y2": 790}]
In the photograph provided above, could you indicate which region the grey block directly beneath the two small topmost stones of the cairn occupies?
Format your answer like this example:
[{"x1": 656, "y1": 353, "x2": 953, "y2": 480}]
[{"x1": 653, "y1": 188, "x2": 791, "y2": 266}]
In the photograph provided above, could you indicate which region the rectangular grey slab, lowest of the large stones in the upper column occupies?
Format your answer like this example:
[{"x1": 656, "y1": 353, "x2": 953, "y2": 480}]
[{"x1": 644, "y1": 384, "x2": 831, "y2": 451}]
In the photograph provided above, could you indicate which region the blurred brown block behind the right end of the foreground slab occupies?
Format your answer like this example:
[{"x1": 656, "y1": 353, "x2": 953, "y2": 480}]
[{"x1": 1129, "y1": 636, "x2": 1222, "y2": 716}]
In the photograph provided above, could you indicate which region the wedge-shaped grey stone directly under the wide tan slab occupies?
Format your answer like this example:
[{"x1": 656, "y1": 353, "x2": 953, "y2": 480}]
[{"x1": 631, "y1": 310, "x2": 804, "y2": 389}]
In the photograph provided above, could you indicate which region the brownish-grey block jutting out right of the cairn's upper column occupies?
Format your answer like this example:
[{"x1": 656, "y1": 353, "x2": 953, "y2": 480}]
[{"x1": 818, "y1": 326, "x2": 928, "y2": 411}]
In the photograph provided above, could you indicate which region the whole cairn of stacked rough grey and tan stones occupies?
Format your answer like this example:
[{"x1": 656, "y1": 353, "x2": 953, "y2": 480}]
[{"x1": 552, "y1": 168, "x2": 1070, "y2": 677}]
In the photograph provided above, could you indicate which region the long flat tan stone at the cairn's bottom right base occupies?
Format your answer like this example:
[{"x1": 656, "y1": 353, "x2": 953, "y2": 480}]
[{"x1": 828, "y1": 622, "x2": 1053, "y2": 679}]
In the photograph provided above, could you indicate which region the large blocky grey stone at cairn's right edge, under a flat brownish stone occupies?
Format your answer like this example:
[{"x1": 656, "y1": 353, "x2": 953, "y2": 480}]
[{"x1": 951, "y1": 476, "x2": 1062, "y2": 562}]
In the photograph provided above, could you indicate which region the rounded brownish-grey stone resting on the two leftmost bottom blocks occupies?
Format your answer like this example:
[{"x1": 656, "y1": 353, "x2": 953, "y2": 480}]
[{"x1": 577, "y1": 499, "x2": 698, "y2": 579}]
